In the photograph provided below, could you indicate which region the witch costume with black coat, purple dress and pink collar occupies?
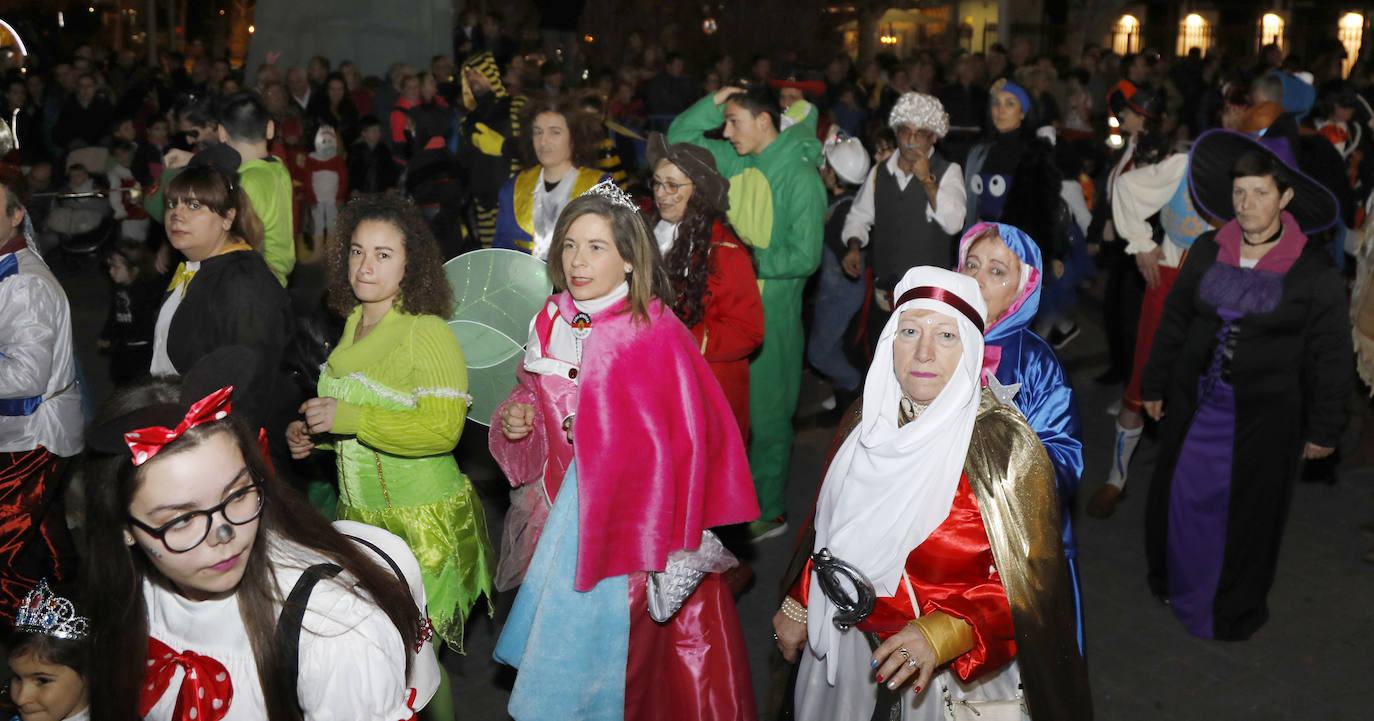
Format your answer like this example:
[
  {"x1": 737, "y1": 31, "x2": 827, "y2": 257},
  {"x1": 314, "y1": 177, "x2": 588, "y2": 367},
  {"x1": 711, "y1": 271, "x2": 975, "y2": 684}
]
[{"x1": 1142, "y1": 213, "x2": 1352, "y2": 640}]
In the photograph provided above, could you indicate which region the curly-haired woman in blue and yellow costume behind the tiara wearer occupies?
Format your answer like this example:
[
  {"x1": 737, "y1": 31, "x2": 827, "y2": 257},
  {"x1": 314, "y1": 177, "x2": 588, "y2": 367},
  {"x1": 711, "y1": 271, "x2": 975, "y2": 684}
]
[{"x1": 492, "y1": 91, "x2": 610, "y2": 260}]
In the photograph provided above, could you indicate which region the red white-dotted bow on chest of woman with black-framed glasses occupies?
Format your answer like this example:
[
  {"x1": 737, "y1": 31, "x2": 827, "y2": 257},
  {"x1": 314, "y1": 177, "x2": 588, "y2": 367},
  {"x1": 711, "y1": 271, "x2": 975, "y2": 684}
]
[{"x1": 139, "y1": 637, "x2": 234, "y2": 721}]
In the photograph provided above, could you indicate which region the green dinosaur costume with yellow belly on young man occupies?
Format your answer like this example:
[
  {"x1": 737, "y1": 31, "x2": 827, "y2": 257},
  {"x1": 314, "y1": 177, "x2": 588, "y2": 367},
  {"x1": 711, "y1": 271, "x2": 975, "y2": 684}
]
[{"x1": 668, "y1": 95, "x2": 826, "y2": 519}]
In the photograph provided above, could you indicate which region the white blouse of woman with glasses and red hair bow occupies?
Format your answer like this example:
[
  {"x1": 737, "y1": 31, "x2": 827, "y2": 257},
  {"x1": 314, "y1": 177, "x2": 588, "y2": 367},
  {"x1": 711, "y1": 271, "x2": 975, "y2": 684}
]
[{"x1": 143, "y1": 522, "x2": 438, "y2": 721}]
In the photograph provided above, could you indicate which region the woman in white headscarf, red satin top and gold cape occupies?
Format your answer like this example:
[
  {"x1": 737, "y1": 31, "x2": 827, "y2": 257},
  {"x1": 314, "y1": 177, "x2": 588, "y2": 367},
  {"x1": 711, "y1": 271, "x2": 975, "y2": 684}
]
[{"x1": 774, "y1": 266, "x2": 1092, "y2": 721}]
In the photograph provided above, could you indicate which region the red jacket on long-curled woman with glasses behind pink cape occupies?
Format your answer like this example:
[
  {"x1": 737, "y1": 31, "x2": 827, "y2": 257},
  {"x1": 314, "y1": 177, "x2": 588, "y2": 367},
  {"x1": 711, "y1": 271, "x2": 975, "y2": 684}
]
[{"x1": 691, "y1": 220, "x2": 764, "y2": 441}]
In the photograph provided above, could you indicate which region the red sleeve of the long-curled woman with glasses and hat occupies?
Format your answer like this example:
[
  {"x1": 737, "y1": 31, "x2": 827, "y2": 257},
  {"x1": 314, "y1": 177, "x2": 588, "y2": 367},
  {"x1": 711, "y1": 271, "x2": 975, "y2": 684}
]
[{"x1": 692, "y1": 224, "x2": 764, "y2": 363}]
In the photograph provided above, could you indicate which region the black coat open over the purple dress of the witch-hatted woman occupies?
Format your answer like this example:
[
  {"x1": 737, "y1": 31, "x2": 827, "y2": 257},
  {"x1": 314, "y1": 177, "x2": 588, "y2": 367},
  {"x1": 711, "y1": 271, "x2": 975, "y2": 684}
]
[{"x1": 1140, "y1": 232, "x2": 1353, "y2": 639}]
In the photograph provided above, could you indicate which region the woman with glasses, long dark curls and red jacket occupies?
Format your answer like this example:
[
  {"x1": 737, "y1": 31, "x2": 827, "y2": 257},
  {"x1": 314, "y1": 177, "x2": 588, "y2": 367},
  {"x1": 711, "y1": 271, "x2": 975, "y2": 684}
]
[{"x1": 647, "y1": 133, "x2": 764, "y2": 434}]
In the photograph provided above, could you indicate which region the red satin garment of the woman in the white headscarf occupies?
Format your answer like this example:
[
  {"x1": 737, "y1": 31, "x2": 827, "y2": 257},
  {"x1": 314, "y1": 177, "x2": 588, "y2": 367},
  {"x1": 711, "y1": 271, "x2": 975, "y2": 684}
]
[{"x1": 790, "y1": 474, "x2": 1017, "y2": 681}]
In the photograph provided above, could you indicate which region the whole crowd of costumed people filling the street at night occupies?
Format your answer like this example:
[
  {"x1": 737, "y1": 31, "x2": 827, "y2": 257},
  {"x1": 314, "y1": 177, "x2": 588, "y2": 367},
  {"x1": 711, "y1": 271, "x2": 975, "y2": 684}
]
[{"x1": 0, "y1": 12, "x2": 1374, "y2": 721}]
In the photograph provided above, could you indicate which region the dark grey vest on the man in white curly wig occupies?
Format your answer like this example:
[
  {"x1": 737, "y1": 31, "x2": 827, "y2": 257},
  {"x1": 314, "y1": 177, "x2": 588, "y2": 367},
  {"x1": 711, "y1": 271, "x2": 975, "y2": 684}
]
[{"x1": 868, "y1": 152, "x2": 954, "y2": 290}]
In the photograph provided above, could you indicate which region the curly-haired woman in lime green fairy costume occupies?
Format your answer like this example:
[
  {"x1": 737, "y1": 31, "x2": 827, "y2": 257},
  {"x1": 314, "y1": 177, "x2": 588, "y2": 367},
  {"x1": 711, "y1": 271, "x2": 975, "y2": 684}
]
[{"x1": 287, "y1": 195, "x2": 492, "y2": 714}]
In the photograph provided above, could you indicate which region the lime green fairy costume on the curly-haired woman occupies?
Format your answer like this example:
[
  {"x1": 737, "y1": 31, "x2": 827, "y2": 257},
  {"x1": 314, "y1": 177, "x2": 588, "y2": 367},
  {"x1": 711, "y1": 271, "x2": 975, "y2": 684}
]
[{"x1": 319, "y1": 306, "x2": 495, "y2": 650}]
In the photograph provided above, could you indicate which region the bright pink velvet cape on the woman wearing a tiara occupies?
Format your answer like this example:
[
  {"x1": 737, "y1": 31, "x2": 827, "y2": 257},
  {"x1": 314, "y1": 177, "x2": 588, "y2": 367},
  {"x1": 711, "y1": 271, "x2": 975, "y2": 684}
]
[{"x1": 524, "y1": 293, "x2": 758, "y2": 591}]
